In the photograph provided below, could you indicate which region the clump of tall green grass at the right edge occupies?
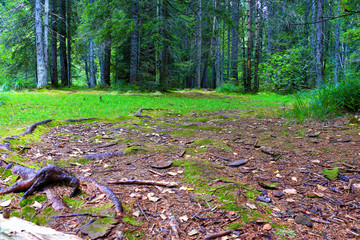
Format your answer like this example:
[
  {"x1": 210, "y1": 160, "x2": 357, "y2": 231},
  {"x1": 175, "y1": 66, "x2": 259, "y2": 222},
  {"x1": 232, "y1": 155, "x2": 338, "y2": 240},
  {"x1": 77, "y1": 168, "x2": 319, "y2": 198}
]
[{"x1": 290, "y1": 80, "x2": 360, "y2": 121}]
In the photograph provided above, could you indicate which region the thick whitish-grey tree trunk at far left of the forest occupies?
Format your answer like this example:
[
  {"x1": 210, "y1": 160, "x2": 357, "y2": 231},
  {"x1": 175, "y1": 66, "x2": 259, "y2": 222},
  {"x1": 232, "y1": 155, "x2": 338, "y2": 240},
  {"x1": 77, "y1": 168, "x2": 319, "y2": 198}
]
[{"x1": 35, "y1": 0, "x2": 47, "y2": 87}]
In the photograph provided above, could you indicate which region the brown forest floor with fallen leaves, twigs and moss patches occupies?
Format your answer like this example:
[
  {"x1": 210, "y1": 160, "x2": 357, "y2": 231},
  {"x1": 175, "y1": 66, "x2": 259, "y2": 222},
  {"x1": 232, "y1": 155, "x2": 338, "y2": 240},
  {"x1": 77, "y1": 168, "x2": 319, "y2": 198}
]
[{"x1": 0, "y1": 95, "x2": 360, "y2": 239}]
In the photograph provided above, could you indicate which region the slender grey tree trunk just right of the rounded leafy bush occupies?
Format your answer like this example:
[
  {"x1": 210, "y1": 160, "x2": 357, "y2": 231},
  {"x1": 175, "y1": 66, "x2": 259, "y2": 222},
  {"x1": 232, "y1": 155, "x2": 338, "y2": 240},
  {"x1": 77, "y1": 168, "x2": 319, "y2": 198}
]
[{"x1": 316, "y1": 0, "x2": 324, "y2": 87}]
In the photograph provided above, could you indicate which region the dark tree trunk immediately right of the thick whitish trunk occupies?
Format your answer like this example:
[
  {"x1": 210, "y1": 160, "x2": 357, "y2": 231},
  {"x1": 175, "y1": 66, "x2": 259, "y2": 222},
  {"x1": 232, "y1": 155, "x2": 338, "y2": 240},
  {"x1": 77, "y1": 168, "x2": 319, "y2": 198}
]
[{"x1": 50, "y1": 0, "x2": 59, "y2": 88}]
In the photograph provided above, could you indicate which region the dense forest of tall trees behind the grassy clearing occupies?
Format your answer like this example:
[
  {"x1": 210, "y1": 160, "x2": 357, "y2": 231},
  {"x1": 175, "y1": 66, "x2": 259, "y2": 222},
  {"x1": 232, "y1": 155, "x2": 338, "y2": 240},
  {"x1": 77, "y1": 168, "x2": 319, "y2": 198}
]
[{"x1": 0, "y1": 0, "x2": 360, "y2": 92}]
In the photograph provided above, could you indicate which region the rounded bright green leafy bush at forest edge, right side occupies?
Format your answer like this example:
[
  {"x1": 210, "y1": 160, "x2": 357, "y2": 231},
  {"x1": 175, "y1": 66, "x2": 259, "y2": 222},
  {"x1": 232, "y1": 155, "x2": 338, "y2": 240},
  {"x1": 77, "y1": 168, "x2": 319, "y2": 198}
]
[{"x1": 260, "y1": 48, "x2": 310, "y2": 93}]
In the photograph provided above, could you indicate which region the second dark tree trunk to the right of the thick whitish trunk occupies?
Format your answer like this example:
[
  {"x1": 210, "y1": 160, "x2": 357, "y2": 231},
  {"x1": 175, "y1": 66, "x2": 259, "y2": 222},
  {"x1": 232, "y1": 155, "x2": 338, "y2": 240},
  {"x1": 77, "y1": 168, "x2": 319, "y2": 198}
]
[{"x1": 59, "y1": 0, "x2": 68, "y2": 86}]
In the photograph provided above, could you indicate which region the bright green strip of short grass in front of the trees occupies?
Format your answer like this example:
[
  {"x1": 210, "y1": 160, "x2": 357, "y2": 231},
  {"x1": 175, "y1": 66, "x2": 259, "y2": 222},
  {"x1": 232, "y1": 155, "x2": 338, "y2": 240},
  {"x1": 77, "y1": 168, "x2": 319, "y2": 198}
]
[{"x1": 0, "y1": 90, "x2": 293, "y2": 132}]
